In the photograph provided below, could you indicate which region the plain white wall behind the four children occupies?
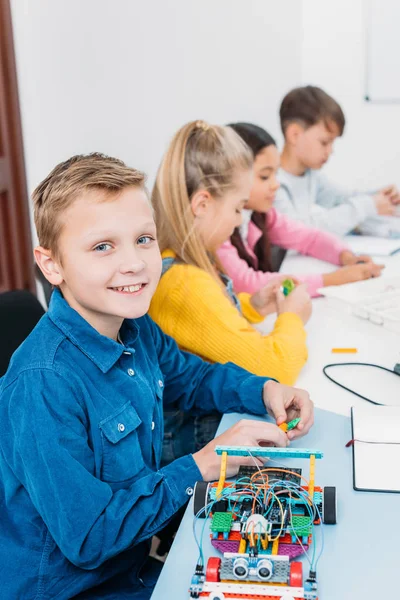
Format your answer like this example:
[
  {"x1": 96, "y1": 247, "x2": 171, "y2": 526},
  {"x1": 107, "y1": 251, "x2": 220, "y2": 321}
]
[{"x1": 12, "y1": 0, "x2": 400, "y2": 227}]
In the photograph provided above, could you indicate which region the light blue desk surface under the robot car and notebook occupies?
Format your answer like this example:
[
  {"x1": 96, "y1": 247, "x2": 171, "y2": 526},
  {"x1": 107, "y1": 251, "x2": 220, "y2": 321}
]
[{"x1": 152, "y1": 409, "x2": 400, "y2": 600}]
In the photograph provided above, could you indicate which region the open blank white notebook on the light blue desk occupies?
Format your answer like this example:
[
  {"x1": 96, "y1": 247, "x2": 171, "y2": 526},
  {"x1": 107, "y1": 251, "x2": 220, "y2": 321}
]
[{"x1": 351, "y1": 403, "x2": 400, "y2": 492}]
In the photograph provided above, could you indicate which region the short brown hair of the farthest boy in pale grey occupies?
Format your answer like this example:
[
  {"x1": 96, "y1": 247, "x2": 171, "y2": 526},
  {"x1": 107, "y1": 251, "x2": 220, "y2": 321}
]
[{"x1": 279, "y1": 85, "x2": 346, "y2": 135}]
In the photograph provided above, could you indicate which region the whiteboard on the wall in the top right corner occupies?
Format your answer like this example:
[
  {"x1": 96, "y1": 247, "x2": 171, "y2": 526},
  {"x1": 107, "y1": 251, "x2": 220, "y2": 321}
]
[{"x1": 364, "y1": 0, "x2": 400, "y2": 103}]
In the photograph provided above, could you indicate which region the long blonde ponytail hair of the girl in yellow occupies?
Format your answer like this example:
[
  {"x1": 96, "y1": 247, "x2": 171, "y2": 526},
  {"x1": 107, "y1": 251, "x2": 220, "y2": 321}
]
[{"x1": 152, "y1": 121, "x2": 253, "y2": 277}]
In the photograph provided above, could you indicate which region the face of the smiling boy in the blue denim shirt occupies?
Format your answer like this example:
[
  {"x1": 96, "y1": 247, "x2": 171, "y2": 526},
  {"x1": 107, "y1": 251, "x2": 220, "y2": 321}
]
[{"x1": 36, "y1": 187, "x2": 161, "y2": 338}]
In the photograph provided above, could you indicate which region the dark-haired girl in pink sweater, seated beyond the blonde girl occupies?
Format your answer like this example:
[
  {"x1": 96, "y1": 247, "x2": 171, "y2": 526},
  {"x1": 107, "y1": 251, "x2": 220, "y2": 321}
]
[{"x1": 218, "y1": 123, "x2": 383, "y2": 296}]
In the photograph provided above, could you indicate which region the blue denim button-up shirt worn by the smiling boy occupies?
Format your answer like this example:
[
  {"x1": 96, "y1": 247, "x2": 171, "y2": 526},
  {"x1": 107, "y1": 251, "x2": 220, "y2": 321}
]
[{"x1": 0, "y1": 291, "x2": 266, "y2": 600}]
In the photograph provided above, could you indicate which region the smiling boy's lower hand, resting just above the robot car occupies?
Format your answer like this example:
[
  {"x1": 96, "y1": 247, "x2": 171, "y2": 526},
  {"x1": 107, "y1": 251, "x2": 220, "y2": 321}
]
[{"x1": 193, "y1": 420, "x2": 292, "y2": 481}]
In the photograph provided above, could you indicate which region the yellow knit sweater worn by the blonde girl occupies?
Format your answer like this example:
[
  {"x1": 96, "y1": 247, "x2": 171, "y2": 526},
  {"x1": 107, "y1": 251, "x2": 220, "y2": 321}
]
[{"x1": 149, "y1": 250, "x2": 307, "y2": 385}]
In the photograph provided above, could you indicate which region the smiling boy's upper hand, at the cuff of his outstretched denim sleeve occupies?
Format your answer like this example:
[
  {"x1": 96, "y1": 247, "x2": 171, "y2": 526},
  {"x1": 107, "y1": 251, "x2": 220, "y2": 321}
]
[{"x1": 263, "y1": 380, "x2": 314, "y2": 440}]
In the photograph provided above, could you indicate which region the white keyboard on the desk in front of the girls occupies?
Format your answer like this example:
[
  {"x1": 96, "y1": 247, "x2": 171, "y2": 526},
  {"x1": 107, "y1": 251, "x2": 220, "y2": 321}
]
[{"x1": 319, "y1": 277, "x2": 400, "y2": 333}]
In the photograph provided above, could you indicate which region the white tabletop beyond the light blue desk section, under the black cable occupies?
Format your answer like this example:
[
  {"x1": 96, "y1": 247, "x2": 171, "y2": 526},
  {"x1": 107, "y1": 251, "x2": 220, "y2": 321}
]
[{"x1": 258, "y1": 255, "x2": 400, "y2": 415}]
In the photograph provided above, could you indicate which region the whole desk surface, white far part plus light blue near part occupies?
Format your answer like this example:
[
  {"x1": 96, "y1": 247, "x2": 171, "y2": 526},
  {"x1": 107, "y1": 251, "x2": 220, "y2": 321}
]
[{"x1": 152, "y1": 248, "x2": 400, "y2": 600}]
